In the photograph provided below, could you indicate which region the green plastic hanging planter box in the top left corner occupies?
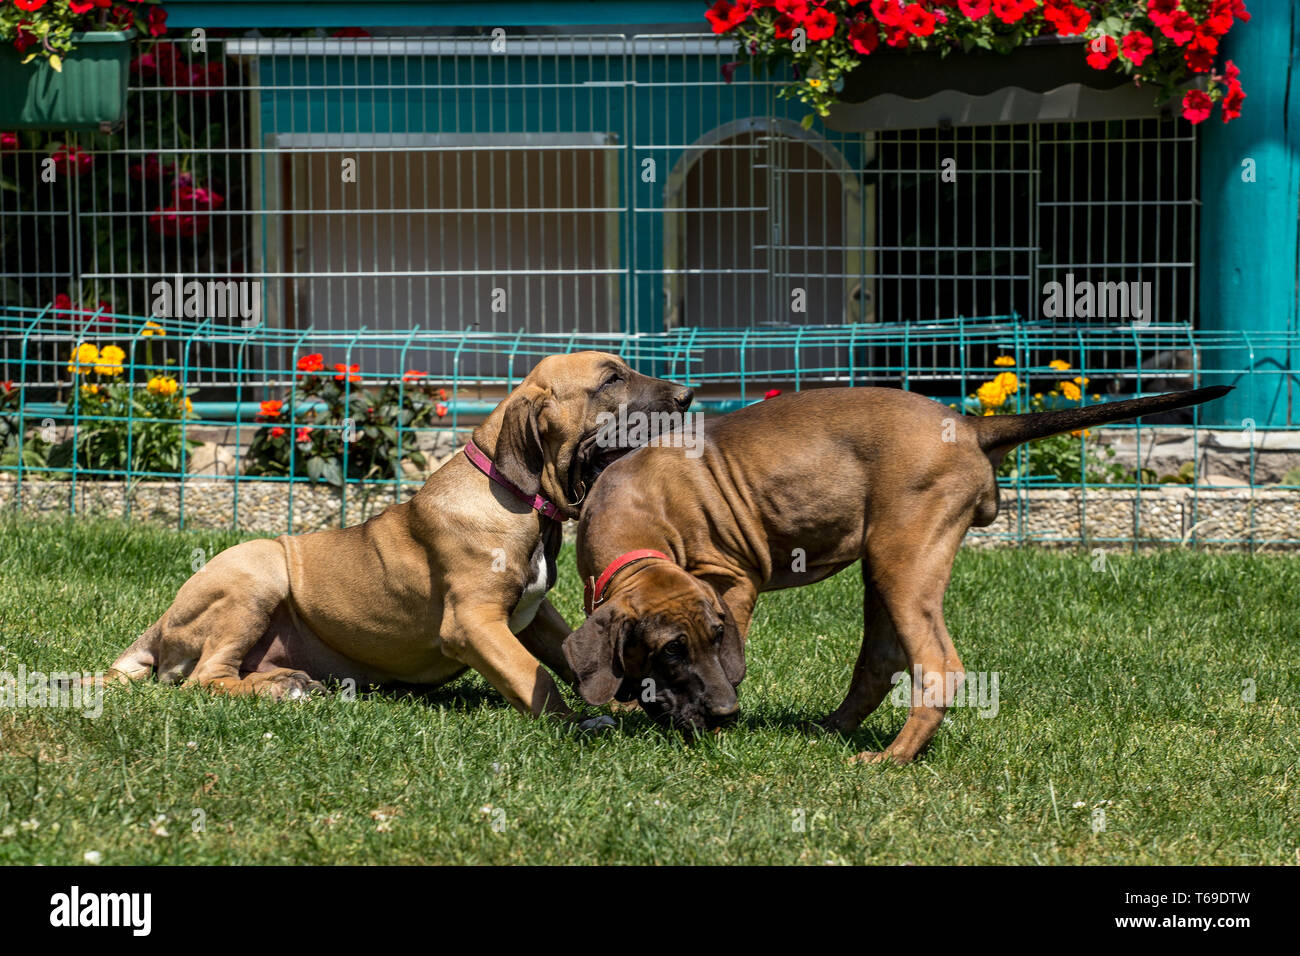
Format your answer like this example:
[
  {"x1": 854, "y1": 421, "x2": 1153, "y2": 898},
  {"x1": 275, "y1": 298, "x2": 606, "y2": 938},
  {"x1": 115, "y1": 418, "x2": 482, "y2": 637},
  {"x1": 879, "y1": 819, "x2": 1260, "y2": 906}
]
[{"x1": 0, "y1": 33, "x2": 131, "y2": 130}]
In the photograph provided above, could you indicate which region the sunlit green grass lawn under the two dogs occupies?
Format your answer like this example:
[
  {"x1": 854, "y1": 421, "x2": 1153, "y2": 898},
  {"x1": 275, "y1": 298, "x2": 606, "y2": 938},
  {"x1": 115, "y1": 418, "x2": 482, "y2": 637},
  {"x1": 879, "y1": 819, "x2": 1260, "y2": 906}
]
[{"x1": 0, "y1": 522, "x2": 1300, "y2": 864}]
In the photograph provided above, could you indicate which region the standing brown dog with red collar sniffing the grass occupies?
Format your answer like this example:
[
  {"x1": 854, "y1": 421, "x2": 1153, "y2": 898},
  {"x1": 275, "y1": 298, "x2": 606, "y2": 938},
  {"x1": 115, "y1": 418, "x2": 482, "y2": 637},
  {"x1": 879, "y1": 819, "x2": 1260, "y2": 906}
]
[{"x1": 563, "y1": 388, "x2": 1230, "y2": 763}]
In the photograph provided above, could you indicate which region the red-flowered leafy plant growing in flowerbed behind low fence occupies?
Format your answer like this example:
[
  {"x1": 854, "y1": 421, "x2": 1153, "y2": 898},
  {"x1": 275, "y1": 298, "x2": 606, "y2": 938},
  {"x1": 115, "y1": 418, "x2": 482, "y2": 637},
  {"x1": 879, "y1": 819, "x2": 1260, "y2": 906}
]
[{"x1": 244, "y1": 352, "x2": 447, "y2": 486}]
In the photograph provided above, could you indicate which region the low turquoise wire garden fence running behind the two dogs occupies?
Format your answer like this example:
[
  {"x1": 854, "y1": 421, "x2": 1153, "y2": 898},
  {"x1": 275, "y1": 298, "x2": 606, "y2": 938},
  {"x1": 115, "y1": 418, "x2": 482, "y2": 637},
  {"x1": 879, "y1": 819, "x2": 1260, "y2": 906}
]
[{"x1": 0, "y1": 308, "x2": 1300, "y2": 548}]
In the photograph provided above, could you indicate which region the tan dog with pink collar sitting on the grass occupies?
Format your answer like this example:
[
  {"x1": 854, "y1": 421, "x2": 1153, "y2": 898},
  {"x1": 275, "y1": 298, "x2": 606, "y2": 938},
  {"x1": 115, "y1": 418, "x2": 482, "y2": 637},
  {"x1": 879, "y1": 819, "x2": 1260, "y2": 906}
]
[{"x1": 112, "y1": 352, "x2": 692, "y2": 715}]
